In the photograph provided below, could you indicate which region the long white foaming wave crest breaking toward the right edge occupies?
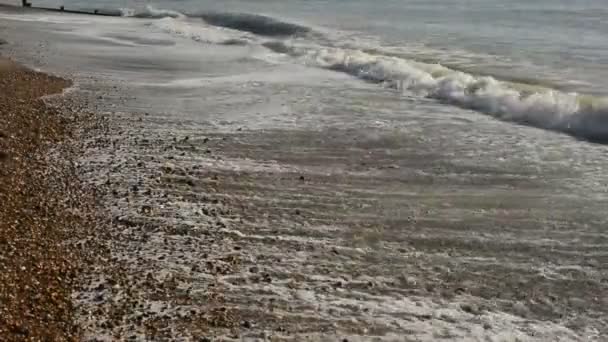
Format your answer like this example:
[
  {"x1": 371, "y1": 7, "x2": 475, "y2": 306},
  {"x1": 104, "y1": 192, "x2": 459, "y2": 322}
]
[{"x1": 264, "y1": 42, "x2": 608, "y2": 143}]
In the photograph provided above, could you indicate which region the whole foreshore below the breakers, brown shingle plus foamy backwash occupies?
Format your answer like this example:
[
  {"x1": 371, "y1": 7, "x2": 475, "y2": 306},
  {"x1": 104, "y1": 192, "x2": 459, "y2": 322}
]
[{"x1": 0, "y1": 2, "x2": 608, "y2": 341}]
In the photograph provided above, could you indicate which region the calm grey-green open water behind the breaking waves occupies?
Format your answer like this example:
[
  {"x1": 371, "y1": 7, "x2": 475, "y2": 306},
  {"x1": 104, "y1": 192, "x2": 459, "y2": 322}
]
[{"x1": 27, "y1": 0, "x2": 608, "y2": 94}]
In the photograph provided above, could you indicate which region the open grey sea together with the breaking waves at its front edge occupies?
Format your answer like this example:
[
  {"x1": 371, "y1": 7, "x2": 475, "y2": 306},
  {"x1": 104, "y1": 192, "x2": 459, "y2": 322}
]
[{"x1": 17, "y1": 0, "x2": 608, "y2": 142}]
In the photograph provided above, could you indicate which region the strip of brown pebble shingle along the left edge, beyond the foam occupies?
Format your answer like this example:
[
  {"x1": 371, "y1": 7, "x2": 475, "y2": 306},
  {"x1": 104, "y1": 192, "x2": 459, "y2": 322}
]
[{"x1": 0, "y1": 59, "x2": 90, "y2": 341}]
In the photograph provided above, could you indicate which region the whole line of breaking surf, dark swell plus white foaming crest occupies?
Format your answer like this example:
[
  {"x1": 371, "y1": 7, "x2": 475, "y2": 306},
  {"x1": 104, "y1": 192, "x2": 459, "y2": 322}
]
[{"x1": 82, "y1": 6, "x2": 608, "y2": 144}]
